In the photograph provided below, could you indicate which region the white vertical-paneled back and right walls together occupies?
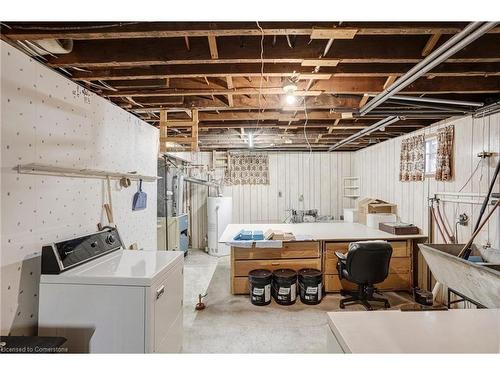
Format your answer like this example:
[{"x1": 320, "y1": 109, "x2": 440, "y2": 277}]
[{"x1": 180, "y1": 114, "x2": 500, "y2": 254}]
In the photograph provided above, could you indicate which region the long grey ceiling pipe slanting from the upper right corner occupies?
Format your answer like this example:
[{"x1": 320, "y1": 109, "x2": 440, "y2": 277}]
[{"x1": 359, "y1": 22, "x2": 497, "y2": 116}]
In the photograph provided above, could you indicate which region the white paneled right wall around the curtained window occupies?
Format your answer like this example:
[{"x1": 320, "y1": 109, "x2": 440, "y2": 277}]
[{"x1": 354, "y1": 114, "x2": 500, "y2": 250}]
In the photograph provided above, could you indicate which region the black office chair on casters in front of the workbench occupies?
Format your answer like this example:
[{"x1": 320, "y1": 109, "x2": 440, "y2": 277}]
[{"x1": 335, "y1": 241, "x2": 392, "y2": 310}]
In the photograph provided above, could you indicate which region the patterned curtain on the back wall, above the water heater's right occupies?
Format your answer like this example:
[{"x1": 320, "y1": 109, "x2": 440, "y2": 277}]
[{"x1": 224, "y1": 153, "x2": 269, "y2": 185}]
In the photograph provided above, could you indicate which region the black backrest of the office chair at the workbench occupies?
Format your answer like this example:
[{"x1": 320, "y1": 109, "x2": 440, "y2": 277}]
[{"x1": 346, "y1": 241, "x2": 392, "y2": 284}]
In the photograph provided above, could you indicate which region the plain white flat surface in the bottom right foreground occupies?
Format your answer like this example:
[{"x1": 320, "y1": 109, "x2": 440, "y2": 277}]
[{"x1": 328, "y1": 309, "x2": 500, "y2": 353}]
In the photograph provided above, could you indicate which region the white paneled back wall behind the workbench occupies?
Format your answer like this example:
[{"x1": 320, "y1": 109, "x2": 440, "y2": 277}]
[{"x1": 187, "y1": 152, "x2": 354, "y2": 248}]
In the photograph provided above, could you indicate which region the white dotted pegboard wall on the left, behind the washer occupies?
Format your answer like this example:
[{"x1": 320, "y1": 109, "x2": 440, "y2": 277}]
[{"x1": 0, "y1": 41, "x2": 158, "y2": 335}]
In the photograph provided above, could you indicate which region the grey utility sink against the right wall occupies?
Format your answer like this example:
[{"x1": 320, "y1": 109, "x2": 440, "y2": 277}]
[{"x1": 418, "y1": 244, "x2": 500, "y2": 308}]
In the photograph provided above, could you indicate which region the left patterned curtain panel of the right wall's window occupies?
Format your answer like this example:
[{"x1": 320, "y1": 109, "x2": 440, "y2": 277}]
[{"x1": 399, "y1": 135, "x2": 425, "y2": 181}]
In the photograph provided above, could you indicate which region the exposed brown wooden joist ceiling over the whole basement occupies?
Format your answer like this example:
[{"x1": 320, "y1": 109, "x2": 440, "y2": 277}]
[{"x1": 2, "y1": 22, "x2": 500, "y2": 151}]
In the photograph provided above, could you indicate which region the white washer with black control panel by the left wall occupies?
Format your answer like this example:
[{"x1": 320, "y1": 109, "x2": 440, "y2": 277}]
[{"x1": 39, "y1": 229, "x2": 184, "y2": 353}]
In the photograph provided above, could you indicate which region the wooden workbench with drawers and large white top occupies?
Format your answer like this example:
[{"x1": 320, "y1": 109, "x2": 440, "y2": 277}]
[{"x1": 219, "y1": 222, "x2": 426, "y2": 294}]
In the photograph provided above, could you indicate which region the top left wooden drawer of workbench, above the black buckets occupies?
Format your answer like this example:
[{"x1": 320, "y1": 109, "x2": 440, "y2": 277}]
[{"x1": 233, "y1": 241, "x2": 320, "y2": 260}]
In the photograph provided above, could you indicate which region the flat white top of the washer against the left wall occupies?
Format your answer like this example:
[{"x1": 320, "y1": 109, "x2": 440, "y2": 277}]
[{"x1": 40, "y1": 250, "x2": 184, "y2": 286}]
